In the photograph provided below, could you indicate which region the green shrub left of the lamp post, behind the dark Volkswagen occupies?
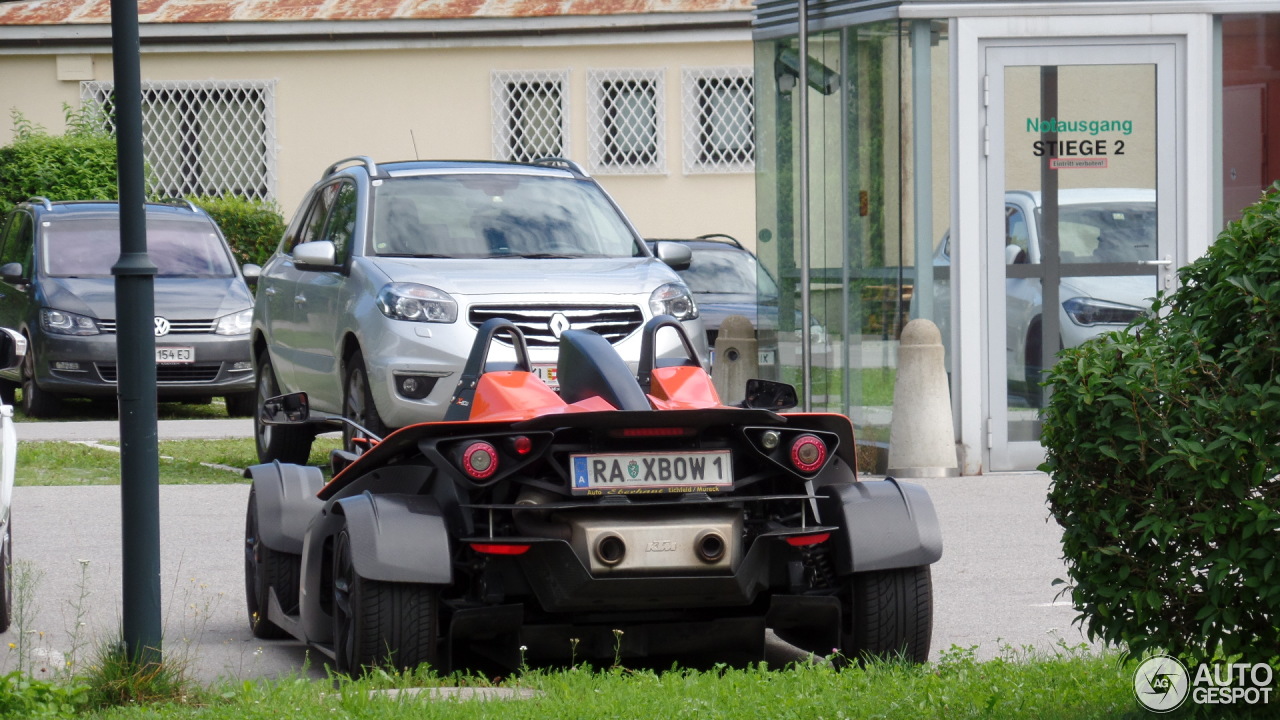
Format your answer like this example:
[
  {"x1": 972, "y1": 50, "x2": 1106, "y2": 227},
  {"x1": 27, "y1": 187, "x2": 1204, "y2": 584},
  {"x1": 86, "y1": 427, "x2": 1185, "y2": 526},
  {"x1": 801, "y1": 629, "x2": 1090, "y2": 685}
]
[{"x1": 0, "y1": 105, "x2": 119, "y2": 213}]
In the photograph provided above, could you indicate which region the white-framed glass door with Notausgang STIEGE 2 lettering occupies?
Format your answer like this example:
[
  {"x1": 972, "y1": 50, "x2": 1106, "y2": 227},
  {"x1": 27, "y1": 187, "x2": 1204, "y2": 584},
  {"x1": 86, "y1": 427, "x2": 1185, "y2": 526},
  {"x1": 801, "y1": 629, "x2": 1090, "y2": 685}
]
[{"x1": 984, "y1": 41, "x2": 1178, "y2": 470}]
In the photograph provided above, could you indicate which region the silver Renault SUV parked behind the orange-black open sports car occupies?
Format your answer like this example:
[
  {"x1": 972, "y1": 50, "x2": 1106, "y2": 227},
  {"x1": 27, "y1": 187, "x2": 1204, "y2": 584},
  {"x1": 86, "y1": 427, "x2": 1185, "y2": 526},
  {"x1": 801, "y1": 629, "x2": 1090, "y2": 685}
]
[{"x1": 252, "y1": 156, "x2": 707, "y2": 462}]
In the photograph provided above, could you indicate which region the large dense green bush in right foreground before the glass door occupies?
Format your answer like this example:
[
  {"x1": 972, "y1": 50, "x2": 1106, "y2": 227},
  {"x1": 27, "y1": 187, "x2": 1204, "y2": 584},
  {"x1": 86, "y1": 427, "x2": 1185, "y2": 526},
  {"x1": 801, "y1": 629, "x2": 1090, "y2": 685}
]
[{"x1": 1041, "y1": 183, "x2": 1280, "y2": 665}]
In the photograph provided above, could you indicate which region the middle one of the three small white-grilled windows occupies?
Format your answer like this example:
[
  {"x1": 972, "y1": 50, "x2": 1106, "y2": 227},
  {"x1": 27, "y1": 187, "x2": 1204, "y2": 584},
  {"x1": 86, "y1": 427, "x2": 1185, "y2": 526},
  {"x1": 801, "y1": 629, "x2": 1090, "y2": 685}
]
[{"x1": 586, "y1": 68, "x2": 667, "y2": 174}]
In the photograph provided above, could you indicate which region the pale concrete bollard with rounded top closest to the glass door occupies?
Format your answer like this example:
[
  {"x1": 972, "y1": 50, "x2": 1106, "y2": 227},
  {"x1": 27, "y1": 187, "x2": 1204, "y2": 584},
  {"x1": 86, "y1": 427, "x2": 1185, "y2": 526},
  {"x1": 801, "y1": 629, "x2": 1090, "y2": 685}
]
[{"x1": 887, "y1": 319, "x2": 960, "y2": 478}]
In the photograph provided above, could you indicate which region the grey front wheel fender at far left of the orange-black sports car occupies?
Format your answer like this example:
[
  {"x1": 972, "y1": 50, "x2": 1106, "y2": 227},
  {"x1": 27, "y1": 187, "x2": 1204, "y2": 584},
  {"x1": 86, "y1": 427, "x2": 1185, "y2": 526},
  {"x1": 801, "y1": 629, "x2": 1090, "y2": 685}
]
[{"x1": 246, "y1": 461, "x2": 324, "y2": 555}]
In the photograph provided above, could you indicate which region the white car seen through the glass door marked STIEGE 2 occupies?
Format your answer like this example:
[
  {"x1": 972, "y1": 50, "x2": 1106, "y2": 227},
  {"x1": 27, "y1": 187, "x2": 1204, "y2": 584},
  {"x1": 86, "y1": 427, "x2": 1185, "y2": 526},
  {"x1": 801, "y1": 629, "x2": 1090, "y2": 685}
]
[{"x1": 933, "y1": 188, "x2": 1156, "y2": 407}]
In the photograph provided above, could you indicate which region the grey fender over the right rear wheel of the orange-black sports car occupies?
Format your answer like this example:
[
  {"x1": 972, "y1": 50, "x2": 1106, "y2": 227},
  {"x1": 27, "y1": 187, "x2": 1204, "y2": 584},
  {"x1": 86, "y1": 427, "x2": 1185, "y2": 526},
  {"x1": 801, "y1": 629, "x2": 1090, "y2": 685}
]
[{"x1": 818, "y1": 478, "x2": 942, "y2": 574}]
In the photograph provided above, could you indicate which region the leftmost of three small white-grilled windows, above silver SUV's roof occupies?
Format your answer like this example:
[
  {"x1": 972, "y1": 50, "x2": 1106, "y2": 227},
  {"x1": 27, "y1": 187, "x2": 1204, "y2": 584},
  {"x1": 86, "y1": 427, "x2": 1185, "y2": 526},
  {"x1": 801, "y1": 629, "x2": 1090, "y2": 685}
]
[{"x1": 490, "y1": 70, "x2": 571, "y2": 161}]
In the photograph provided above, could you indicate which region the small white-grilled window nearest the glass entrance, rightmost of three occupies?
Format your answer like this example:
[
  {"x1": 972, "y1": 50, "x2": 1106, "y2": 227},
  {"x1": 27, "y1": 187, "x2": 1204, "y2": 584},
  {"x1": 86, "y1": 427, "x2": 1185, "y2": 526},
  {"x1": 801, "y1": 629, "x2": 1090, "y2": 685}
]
[{"x1": 681, "y1": 67, "x2": 755, "y2": 174}]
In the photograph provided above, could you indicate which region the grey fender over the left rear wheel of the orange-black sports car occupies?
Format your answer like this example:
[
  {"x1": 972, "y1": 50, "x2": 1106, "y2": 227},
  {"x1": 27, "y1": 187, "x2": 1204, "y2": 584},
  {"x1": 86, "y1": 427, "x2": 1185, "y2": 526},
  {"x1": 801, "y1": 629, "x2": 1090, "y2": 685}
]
[{"x1": 334, "y1": 492, "x2": 453, "y2": 584}]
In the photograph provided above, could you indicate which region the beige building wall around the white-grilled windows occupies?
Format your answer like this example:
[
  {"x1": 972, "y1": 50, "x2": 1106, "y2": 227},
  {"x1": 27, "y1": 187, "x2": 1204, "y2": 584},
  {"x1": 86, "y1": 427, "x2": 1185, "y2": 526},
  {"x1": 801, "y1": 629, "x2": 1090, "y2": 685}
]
[{"x1": 0, "y1": 37, "x2": 755, "y2": 247}]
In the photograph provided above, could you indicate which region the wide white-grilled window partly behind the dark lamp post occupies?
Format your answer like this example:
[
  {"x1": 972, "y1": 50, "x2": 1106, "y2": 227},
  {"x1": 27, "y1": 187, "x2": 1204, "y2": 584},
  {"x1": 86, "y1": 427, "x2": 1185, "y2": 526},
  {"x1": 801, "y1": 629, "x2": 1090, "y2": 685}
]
[{"x1": 81, "y1": 81, "x2": 275, "y2": 200}]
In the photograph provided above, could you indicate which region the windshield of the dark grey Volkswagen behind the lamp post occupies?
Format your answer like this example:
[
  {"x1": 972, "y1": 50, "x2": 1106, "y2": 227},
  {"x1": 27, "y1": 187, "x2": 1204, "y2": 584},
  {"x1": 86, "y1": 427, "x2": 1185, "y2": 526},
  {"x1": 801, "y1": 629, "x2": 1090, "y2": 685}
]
[{"x1": 42, "y1": 218, "x2": 236, "y2": 278}]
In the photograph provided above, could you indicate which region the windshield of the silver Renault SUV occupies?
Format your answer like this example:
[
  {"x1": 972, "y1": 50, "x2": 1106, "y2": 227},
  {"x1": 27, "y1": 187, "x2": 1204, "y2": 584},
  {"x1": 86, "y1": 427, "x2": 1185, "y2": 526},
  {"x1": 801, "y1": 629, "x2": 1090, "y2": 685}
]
[{"x1": 372, "y1": 174, "x2": 644, "y2": 258}]
